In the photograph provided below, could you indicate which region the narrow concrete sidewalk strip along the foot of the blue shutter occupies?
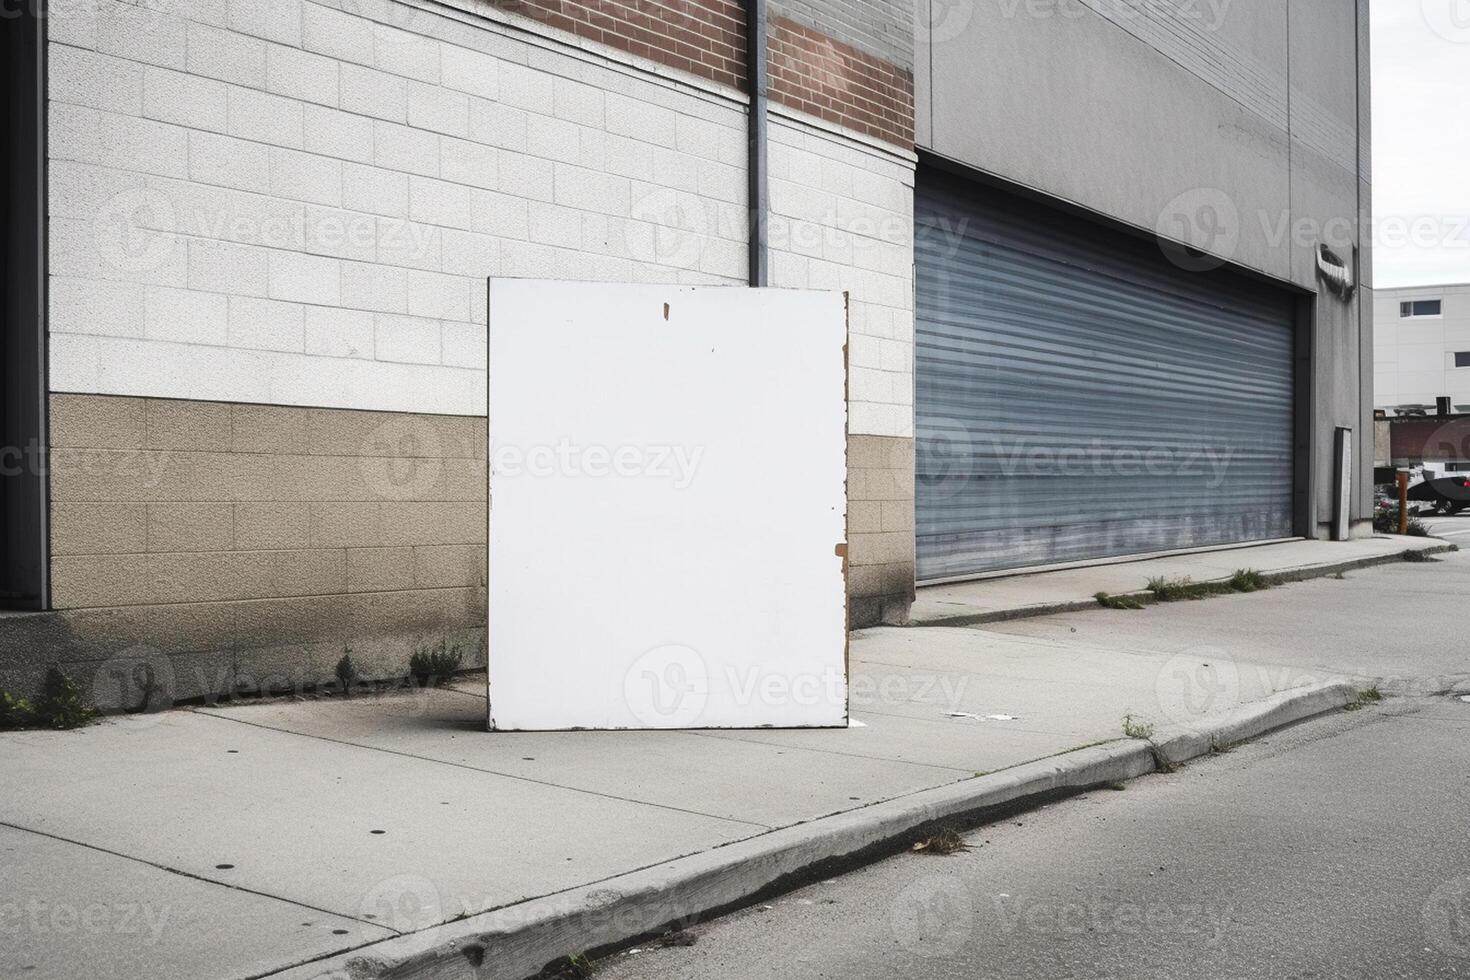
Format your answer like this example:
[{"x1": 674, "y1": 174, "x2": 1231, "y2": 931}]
[{"x1": 911, "y1": 535, "x2": 1448, "y2": 626}]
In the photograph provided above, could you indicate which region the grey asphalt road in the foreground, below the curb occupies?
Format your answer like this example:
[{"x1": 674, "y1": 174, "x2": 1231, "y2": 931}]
[{"x1": 598, "y1": 696, "x2": 1470, "y2": 980}]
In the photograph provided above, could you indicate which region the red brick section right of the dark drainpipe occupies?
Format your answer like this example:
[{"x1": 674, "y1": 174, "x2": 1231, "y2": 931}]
[{"x1": 769, "y1": 18, "x2": 914, "y2": 148}]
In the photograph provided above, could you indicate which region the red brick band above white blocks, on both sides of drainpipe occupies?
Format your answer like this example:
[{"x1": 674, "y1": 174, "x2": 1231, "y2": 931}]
[{"x1": 494, "y1": 0, "x2": 914, "y2": 148}]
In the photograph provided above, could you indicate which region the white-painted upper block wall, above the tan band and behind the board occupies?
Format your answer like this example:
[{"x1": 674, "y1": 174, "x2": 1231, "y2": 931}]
[{"x1": 50, "y1": 0, "x2": 914, "y2": 436}]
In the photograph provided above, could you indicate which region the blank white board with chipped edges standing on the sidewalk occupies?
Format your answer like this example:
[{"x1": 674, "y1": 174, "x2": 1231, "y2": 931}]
[{"x1": 490, "y1": 279, "x2": 847, "y2": 730}]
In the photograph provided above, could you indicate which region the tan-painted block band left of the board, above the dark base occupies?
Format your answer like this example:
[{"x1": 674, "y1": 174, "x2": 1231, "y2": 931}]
[{"x1": 51, "y1": 395, "x2": 487, "y2": 608}]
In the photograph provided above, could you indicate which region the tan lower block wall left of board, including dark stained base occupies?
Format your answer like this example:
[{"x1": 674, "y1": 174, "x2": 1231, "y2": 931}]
[{"x1": 30, "y1": 394, "x2": 487, "y2": 699}]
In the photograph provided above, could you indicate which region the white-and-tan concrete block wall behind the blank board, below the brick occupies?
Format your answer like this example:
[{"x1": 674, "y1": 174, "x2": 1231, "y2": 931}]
[{"x1": 35, "y1": 0, "x2": 914, "y2": 693}]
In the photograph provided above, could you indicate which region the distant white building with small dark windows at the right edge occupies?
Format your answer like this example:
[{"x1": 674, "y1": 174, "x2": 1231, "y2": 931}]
[{"x1": 1373, "y1": 284, "x2": 1470, "y2": 414}]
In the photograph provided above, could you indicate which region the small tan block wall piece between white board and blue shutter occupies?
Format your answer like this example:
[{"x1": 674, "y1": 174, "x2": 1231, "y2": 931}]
[{"x1": 847, "y1": 435, "x2": 914, "y2": 629}]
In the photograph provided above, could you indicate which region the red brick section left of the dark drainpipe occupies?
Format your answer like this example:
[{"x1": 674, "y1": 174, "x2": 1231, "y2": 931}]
[{"x1": 494, "y1": 0, "x2": 745, "y2": 88}]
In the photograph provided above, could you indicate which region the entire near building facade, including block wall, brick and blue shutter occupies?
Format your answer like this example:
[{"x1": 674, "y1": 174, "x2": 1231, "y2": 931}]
[{"x1": 0, "y1": 0, "x2": 1373, "y2": 698}]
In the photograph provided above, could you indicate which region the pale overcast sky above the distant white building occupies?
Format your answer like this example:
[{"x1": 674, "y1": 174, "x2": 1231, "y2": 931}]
[{"x1": 1372, "y1": 0, "x2": 1470, "y2": 289}]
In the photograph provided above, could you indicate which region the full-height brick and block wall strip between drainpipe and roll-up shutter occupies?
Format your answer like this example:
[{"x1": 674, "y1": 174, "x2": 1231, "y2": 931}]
[{"x1": 769, "y1": 0, "x2": 914, "y2": 626}]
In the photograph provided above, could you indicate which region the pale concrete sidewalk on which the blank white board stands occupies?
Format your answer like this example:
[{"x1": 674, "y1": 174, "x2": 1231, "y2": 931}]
[{"x1": 0, "y1": 543, "x2": 1470, "y2": 980}]
